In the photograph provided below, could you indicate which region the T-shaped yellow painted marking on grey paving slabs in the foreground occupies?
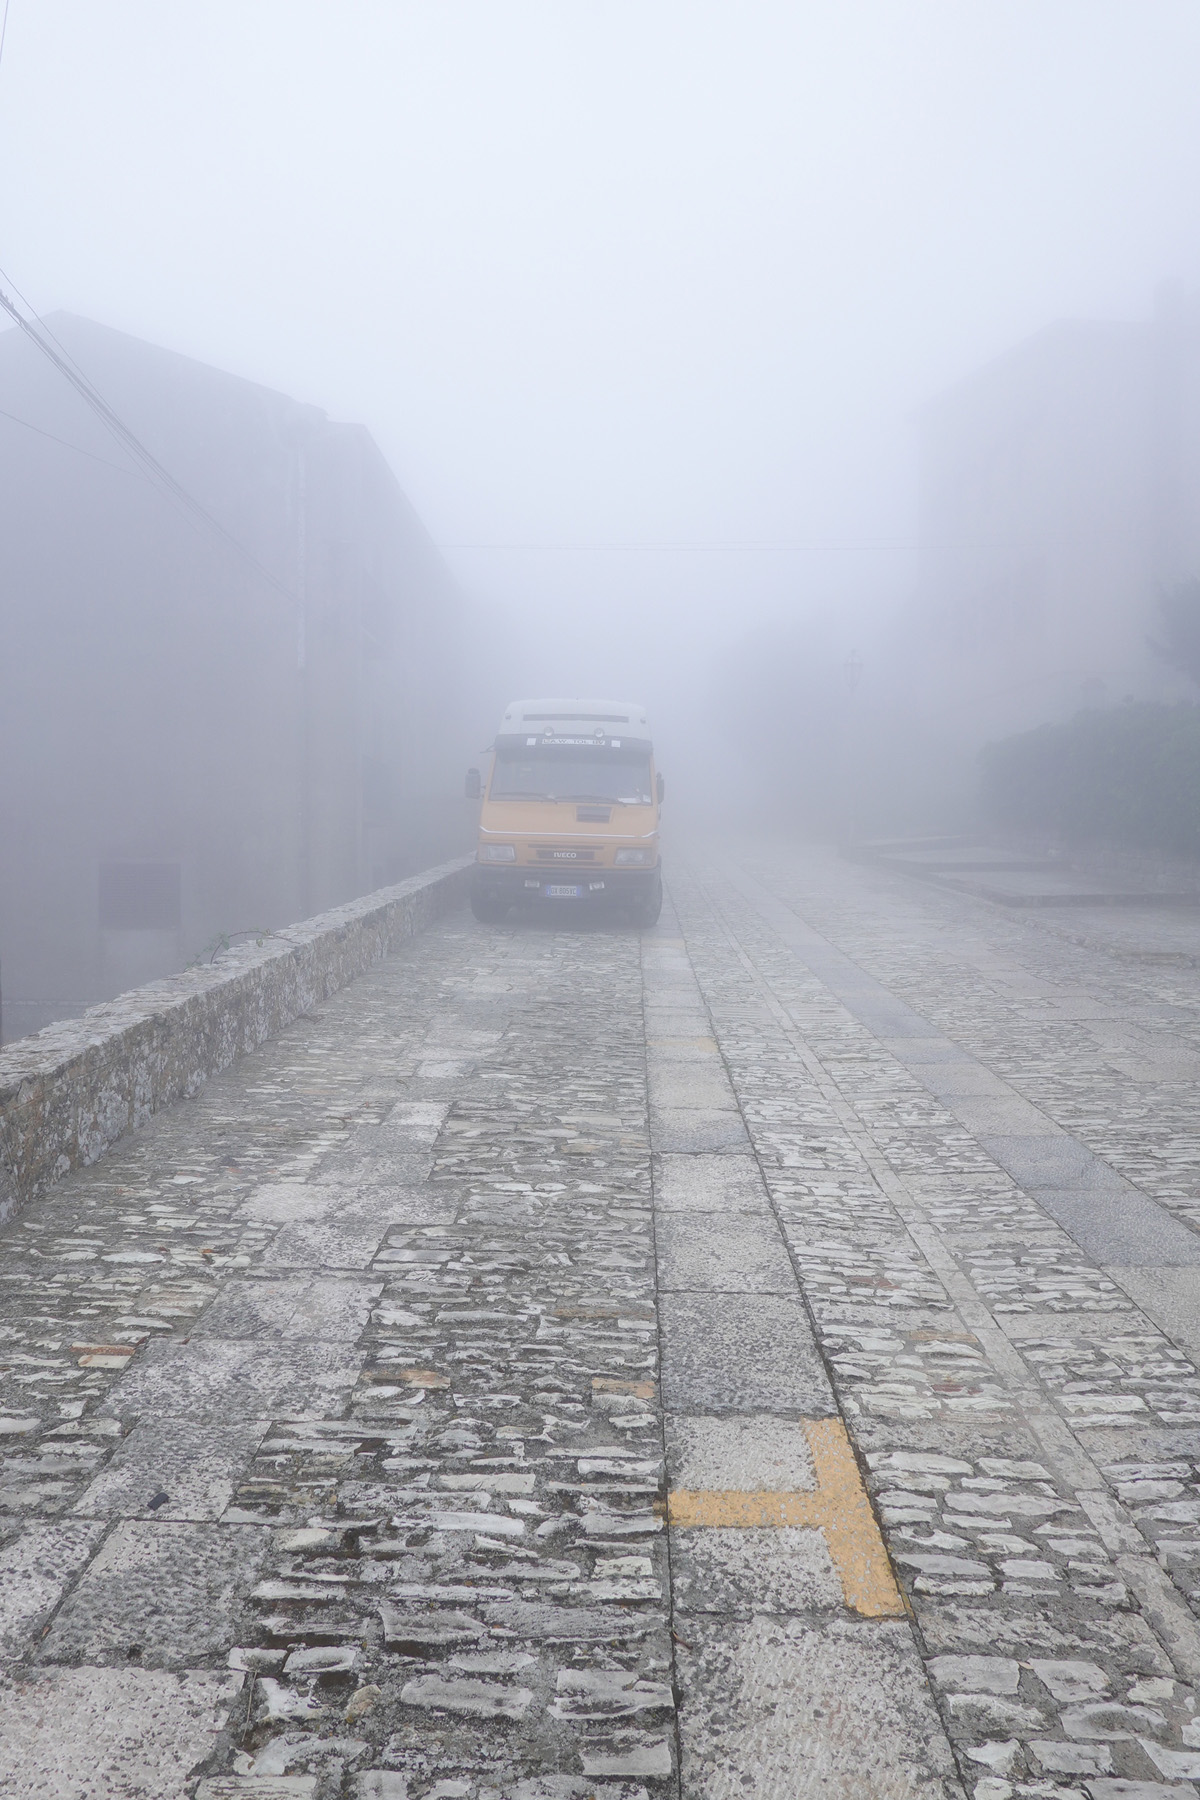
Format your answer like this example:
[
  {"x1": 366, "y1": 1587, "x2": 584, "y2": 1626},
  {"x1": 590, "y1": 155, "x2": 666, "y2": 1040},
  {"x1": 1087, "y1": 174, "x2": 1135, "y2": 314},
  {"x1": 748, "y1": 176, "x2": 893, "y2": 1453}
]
[{"x1": 667, "y1": 1418, "x2": 905, "y2": 1618}]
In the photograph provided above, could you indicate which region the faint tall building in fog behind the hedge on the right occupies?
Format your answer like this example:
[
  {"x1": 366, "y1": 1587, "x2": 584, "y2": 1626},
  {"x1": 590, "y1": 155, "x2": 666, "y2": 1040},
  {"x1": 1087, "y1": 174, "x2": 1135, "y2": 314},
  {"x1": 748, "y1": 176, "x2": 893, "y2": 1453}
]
[{"x1": 912, "y1": 290, "x2": 1200, "y2": 738}]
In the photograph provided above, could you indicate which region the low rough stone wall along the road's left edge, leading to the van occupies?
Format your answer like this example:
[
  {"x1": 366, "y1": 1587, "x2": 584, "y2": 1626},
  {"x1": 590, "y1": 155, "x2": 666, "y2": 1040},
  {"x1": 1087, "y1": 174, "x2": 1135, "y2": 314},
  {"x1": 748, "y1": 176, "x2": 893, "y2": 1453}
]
[{"x1": 0, "y1": 859, "x2": 471, "y2": 1219}]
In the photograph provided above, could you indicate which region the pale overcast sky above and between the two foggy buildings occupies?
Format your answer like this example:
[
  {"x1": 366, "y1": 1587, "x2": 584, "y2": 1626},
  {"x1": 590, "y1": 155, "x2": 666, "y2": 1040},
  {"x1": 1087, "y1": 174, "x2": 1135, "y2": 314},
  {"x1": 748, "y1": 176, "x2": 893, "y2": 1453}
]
[{"x1": 0, "y1": 0, "x2": 1200, "y2": 687}]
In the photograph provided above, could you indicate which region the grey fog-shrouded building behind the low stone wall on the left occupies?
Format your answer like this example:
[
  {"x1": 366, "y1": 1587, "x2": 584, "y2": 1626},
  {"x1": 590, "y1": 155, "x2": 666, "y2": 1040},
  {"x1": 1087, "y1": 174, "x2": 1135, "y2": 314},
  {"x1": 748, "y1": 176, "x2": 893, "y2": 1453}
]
[{"x1": 0, "y1": 315, "x2": 475, "y2": 1040}]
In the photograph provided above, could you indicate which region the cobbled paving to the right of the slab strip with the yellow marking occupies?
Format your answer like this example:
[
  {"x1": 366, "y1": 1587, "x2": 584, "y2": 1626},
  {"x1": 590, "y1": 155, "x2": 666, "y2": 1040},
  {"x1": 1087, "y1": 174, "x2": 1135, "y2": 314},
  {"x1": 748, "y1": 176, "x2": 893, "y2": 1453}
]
[{"x1": 675, "y1": 857, "x2": 1200, "y2": 1800}]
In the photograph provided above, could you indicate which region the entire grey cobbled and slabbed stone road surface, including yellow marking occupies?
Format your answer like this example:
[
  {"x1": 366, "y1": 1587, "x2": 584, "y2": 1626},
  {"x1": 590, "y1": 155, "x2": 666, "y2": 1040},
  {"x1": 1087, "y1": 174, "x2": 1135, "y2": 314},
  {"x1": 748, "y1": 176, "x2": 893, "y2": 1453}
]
[{"x1": 0, "y1": 850, "x2": 1200, "y2": 1800}]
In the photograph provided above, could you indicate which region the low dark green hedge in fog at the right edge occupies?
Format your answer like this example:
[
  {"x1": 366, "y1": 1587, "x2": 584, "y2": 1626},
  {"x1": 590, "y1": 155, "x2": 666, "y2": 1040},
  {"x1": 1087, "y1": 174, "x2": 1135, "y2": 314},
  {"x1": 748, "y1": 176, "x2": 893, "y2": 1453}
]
[{"x1": 979, "y1": 700, "x2": 1200, "y2": 857}]
